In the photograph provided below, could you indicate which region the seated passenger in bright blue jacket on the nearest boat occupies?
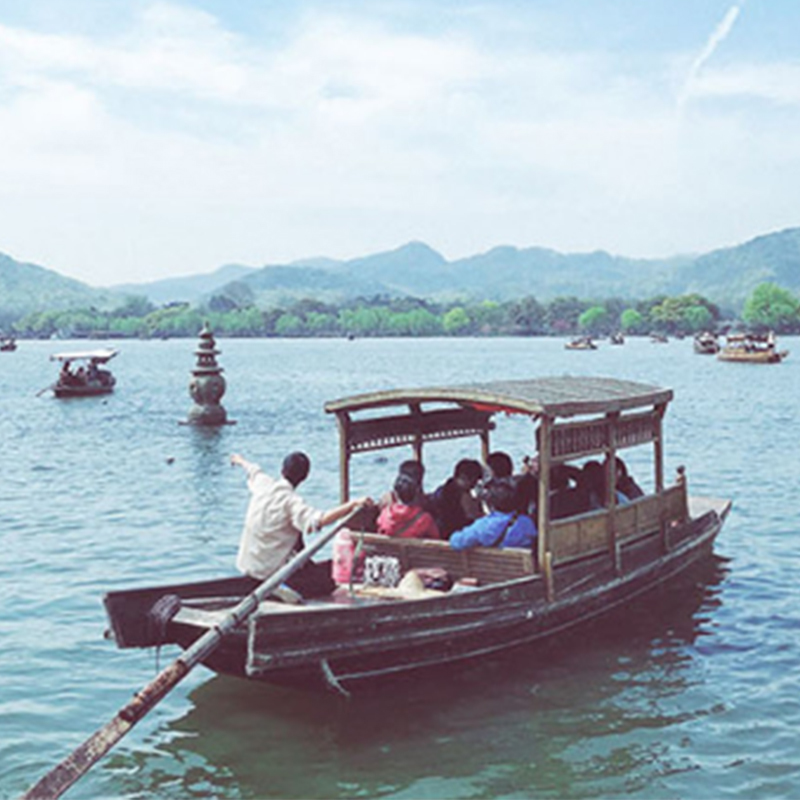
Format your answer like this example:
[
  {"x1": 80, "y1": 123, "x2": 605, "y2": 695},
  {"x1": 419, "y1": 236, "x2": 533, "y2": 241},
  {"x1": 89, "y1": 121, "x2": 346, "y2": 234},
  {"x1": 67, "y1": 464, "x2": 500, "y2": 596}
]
[{"x1": 450, "y1": 478, "x2": 536, "y2": 550}]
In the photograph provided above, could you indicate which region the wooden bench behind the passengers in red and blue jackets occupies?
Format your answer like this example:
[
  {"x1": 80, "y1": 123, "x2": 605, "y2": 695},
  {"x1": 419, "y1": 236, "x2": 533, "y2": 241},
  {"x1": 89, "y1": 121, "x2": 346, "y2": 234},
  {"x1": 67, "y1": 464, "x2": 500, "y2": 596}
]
[{"x1": 353, "y1": 532, "x2": 535, "y2": 585}]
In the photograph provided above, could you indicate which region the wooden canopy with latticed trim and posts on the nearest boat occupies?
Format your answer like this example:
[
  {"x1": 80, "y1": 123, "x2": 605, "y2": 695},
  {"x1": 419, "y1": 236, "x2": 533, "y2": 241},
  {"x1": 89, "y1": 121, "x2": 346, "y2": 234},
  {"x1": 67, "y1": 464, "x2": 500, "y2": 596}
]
[{"x1": 325, "y1": 376, "x2": 673, "y2": 501}]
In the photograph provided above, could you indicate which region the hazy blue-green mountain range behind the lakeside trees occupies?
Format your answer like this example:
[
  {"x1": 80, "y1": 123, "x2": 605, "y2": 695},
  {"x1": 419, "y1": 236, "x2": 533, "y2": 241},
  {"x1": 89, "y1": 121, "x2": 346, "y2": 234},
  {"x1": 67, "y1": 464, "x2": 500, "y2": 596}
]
[{"x1": 0, "y1": 228, "x2": 800, "y2": 326}]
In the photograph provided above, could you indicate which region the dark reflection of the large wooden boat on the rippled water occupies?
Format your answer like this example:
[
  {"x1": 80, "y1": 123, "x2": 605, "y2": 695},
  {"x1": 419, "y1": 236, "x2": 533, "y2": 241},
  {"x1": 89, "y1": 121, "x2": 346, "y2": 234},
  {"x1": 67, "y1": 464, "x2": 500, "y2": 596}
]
[{"x1": 108, "y1": 558, "x2": 726, "y2": 797}]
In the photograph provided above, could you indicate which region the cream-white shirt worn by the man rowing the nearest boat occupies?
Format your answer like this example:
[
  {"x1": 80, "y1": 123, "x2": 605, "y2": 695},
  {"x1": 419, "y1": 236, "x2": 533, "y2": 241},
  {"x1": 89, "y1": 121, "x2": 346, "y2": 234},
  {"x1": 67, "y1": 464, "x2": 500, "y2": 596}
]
[{"x1": 236, "y1": 464, "x2": 324, "y2": 580}]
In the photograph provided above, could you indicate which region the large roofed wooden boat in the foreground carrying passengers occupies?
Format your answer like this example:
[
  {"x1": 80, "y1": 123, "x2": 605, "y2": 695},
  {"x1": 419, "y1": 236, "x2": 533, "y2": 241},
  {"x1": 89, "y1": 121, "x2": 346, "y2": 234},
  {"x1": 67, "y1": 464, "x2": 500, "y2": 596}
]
[{"x1": 104, "y1": 377, "x2": 730, "y2": 691}]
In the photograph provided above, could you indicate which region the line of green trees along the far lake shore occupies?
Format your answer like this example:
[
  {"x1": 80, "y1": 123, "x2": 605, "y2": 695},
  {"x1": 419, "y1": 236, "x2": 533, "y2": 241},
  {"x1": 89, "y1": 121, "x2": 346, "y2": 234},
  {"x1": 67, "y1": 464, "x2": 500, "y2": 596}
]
[{"x1": 7, "y1": 283, "x2": 800, "y2": 338}]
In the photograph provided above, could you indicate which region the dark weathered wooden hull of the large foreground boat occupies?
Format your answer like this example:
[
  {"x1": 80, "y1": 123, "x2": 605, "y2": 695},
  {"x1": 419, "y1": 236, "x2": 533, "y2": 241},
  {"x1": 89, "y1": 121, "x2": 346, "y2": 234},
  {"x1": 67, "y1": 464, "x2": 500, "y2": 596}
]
[{"x1": 105, "y1": 511, "x2": 724, "y2": 689}]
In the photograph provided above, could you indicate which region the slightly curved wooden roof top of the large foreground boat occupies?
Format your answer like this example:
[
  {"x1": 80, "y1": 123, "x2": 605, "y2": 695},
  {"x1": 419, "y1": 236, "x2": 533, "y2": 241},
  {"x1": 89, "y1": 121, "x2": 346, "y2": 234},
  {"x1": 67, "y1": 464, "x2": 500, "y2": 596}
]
[{"x1": 325, "y1": 376, "x2": 673, "y2": 417}]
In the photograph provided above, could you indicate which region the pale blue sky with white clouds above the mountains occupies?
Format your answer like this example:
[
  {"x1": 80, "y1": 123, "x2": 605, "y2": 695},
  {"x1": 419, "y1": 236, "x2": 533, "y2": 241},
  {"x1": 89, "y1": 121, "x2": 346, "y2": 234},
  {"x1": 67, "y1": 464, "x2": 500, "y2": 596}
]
[{"x1": 0, "y1": 0, "x2": 800, "y2": 286}]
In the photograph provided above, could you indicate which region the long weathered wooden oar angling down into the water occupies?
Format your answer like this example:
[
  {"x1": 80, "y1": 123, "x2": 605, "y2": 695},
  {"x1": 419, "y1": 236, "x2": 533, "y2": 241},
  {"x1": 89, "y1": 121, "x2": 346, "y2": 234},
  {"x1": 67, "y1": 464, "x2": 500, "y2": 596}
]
[{"x1": 22, "y1": 505, "x2": 362, "y2": 800}]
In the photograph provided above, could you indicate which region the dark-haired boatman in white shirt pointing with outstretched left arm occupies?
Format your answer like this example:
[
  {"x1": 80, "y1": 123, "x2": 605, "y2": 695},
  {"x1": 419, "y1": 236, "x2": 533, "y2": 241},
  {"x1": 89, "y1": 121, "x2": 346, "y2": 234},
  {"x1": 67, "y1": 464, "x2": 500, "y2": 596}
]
[{"x1": 231, "y1": 452, "x2": 372, "y2": 597}]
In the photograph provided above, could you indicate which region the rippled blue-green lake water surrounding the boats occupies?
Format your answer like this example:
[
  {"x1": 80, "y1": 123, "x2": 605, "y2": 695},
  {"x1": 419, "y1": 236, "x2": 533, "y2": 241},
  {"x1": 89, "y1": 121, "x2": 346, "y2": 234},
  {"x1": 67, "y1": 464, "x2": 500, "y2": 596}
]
[{"x1": 0, "y1": 338, "x2": 800, "y2": 800}]
